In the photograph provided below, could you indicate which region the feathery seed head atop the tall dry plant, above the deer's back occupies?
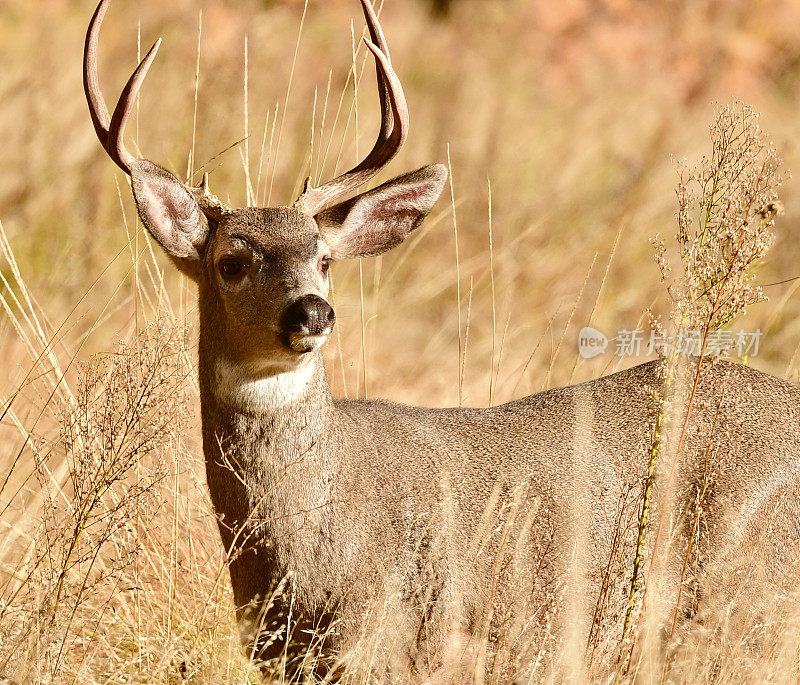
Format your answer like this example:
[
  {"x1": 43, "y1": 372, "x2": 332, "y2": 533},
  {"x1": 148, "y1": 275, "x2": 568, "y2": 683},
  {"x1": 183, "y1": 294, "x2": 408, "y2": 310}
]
[{"x1": 653, "y1": 100, "x2": 787, "y2": 330}]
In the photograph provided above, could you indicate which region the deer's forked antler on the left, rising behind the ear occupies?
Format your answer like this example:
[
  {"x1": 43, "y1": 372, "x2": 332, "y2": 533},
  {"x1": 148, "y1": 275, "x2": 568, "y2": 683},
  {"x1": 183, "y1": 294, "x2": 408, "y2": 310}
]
[{"x1": 83, "y1": 0, "x2": 230, "y2": 218}]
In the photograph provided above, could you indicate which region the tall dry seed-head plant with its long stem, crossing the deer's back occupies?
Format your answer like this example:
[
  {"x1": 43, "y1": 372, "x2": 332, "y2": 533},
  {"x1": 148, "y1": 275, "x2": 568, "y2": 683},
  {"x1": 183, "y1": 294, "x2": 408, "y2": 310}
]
[{"x1": 620, "y1": 100, "x2": 787, "y2": 678}]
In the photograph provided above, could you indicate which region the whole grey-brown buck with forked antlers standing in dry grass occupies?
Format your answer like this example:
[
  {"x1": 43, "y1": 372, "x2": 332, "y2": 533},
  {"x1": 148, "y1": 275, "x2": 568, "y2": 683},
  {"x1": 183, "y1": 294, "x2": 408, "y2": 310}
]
[{"x1": 84, "y1": 0, "x2": 800, "y2": 678}]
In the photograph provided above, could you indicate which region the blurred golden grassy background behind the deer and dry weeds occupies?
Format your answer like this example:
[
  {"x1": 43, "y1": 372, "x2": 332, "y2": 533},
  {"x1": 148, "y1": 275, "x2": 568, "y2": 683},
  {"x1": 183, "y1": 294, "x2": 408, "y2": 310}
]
[{"x1": 0, "y1": 0, "x2": 800, "y2": 680}]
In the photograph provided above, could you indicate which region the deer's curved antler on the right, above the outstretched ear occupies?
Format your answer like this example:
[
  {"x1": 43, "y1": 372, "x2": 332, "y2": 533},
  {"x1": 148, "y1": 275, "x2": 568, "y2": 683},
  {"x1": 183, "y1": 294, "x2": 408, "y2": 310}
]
[{"x1": 292, "y1": 0, "x2": 409, "y2": 216}]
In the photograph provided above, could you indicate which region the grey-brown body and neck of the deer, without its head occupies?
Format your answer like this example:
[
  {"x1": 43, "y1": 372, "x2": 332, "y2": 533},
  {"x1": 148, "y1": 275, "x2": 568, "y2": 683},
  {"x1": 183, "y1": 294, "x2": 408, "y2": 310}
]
[{"x1": 201, "y1": 296, "x2": 800, "y2": 673}]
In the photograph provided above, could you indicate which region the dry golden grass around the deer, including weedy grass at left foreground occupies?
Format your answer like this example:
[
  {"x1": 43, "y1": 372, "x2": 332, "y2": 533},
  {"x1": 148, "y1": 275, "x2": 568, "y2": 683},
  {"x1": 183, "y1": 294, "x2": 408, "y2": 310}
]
[{"x1": 0, "y1": 0, "x2": 800, "y2": 683}]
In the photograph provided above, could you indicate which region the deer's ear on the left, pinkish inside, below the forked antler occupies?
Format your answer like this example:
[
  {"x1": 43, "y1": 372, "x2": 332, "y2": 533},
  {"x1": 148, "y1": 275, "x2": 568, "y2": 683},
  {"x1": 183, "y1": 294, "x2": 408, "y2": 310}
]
[{"x1": 131, "y1": 159, "x2": 209, "y2": 276}]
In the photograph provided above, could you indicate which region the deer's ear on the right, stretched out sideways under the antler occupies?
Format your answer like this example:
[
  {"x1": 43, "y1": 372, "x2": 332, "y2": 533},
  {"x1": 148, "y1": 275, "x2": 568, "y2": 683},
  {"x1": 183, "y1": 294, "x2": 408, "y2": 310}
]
[{"x1": 314, "y1": 164, "x2": 447, "y2": 259}]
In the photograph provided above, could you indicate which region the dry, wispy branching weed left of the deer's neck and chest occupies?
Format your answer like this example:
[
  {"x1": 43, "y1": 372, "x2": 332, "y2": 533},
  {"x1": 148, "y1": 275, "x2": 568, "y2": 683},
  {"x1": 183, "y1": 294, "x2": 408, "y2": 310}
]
[{"x1": 0, "y1": 316, "x2": 191, "y2": 680}]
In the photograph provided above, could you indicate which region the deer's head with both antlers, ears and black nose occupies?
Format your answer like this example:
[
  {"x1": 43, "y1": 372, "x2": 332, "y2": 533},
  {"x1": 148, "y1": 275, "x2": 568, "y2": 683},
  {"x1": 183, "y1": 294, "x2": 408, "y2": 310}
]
[{"x1": 83, "y1": 0, "x2": 447, "y2": 372}]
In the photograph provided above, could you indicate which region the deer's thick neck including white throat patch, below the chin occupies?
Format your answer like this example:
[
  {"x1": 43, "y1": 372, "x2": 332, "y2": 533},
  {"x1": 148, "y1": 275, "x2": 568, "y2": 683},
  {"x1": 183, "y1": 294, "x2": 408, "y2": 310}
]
[{"x1": 200, "y1": 312, "x2": 339, "y2": 560}]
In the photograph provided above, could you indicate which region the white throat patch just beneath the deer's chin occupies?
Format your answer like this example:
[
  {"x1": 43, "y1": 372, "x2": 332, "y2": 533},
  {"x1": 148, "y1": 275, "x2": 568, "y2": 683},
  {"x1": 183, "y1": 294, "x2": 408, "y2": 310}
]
[{"x1": 213, "y1": 359, "x2": 315, "y2": 412}]
